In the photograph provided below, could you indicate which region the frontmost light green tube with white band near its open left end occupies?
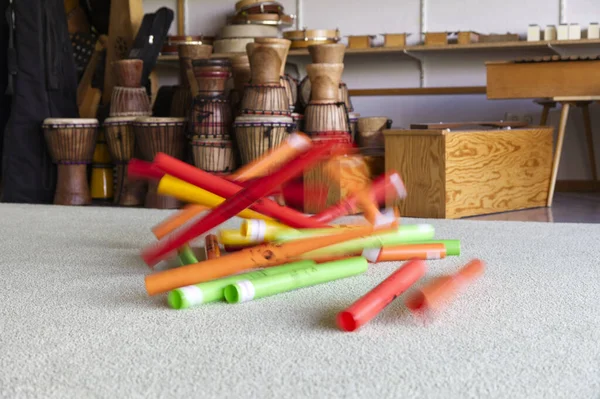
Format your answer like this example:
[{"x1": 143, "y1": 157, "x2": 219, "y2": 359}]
[{"x1": 225, "y1": 256, "x2": 368, "y2": 303}]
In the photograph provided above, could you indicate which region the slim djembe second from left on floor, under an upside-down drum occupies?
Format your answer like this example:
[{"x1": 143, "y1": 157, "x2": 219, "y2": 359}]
[{"x1": 104, "y1": 117, "x2": 147, "y2": 206}]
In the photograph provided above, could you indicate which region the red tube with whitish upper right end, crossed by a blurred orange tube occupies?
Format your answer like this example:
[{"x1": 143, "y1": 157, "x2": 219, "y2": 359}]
[{"x1": 312, "y1": 171, "x2": 406, "y2": 223}]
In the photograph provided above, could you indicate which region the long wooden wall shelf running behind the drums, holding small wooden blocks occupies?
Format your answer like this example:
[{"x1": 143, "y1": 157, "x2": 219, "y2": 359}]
[{"x1": 158, "y1": 39, "x2": 600, "y2": 62}]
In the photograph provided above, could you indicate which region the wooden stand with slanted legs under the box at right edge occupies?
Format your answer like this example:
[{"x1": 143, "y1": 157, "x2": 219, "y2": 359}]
[{"x1": 535, "y1": 96, "x2": 600, "y2": 206}]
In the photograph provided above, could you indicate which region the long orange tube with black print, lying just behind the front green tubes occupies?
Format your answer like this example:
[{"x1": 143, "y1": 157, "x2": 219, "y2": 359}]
[{"x1": 145, "y1": 226, "x2": 390, "y2": 295}]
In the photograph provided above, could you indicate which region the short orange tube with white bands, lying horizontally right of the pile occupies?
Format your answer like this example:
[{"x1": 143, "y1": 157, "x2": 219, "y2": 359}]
[{"x1": 362, "y1": 244, "x2": 446, "y2": 263}]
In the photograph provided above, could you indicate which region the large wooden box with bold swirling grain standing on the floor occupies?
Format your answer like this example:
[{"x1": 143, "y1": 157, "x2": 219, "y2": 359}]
[{"x1": 383, "y1": 126, "x2": 553, "y2": 219}]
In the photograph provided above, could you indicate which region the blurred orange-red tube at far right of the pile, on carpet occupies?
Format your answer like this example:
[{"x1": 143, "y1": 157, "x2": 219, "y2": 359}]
[{"x1": 405, "y1": 259, "x2": 485, "y2": 312}]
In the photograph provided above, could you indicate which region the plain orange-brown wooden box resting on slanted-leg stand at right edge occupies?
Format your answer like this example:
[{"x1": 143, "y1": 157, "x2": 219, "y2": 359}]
[{"x1": 486, "y1": 60, "x2": 600, "y2": 99}]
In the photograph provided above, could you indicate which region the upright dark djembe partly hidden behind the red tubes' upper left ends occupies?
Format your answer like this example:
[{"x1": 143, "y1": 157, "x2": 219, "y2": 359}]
[{"x1": 133, "y1": 117, "x2": 187, "y2": 209}]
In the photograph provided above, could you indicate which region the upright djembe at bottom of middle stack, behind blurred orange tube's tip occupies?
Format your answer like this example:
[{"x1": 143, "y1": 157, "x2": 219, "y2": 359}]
[{"x1": 234, "y1": 115, "x2": 295, "y2": 164}]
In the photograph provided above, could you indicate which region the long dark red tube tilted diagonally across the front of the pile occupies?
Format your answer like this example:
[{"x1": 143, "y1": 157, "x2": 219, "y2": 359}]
[{"x1": 142, "y1": 144, "x2": 344, "y2": 266}]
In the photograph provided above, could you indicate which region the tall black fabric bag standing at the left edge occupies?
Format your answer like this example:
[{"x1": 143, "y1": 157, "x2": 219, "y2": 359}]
[{"x1": 2, "y1": 0, "x2": 79, "y2": 203}]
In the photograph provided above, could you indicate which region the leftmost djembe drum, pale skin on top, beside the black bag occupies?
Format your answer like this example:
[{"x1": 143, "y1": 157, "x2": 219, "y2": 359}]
[{"x1": 42, "y1": 118, "x2": 99, "y2": 205}]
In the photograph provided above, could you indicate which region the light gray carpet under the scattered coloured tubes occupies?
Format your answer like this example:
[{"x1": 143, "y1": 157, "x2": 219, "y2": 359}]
[{"x1": 0, "y1": 205, "x2": 600, "y2": 399}]
